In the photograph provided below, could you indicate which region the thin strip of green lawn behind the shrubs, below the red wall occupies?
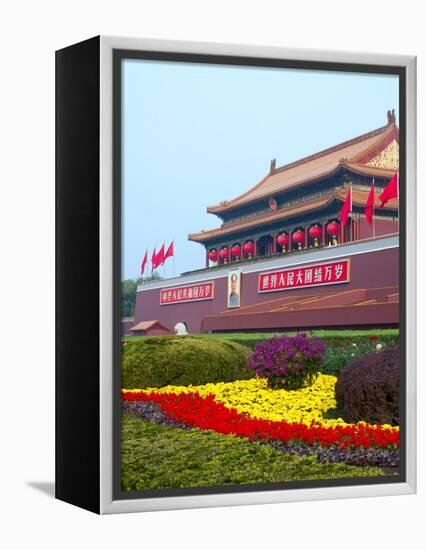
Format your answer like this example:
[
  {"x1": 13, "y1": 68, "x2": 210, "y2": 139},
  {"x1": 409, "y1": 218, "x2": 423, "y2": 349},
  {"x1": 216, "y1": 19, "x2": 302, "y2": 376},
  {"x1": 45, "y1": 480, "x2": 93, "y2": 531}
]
[{"x1": 123, "y1": 328, "x2": 399, "y2": 342}]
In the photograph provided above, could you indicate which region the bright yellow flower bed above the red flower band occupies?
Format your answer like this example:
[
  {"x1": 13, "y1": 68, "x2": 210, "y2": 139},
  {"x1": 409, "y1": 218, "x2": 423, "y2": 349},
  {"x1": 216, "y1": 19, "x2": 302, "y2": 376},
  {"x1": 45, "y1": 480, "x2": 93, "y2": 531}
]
[{"x1": 123, "y1": 374, "x2": 396, "y2": 432}]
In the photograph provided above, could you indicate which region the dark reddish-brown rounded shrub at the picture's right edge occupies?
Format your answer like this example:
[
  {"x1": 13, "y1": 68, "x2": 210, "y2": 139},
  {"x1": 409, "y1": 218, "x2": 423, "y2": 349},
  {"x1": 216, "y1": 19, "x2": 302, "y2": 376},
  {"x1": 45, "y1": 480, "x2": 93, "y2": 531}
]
[{"x1": 336, "y1": 347, "x2": 399, "y2": 426}]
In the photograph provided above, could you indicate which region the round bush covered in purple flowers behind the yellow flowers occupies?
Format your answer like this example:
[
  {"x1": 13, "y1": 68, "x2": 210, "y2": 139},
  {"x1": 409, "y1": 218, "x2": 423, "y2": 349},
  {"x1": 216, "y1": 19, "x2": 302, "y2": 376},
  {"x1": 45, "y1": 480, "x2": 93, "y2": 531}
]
[{"x1": 249, "y1": 332, "x2": 325, "y2": 390}]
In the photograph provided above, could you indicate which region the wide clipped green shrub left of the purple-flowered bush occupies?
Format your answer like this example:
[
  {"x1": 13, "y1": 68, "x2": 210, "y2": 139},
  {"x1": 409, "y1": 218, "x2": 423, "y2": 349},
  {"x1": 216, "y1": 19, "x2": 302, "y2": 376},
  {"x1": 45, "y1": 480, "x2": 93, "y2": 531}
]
[{"x1": 121, "y1": 336, "x2": 253, "y2": 389}]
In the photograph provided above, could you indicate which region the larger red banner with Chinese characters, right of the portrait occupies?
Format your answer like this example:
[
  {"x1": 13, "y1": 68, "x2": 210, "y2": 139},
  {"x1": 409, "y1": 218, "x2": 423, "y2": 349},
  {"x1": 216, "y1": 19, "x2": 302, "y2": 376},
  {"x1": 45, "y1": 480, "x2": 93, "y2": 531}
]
[{"x1": 258, "y1": 260, "x2": 350, "y2": 292}]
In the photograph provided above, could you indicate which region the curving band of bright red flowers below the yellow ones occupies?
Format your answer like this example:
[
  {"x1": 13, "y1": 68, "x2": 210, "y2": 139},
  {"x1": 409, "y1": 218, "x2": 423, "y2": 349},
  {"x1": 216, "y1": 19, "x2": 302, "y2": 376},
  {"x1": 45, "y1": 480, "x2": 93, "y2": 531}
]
[{"x1": 122, "y1": 391, "x2": 399, "y2": 449}]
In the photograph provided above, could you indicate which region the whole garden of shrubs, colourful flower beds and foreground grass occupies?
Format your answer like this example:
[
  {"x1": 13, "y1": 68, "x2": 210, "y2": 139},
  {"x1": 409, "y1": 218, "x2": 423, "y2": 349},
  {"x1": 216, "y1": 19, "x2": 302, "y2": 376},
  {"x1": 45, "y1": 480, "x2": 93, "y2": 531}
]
[{"x1": 122, "y1": 333, "x2": 399, "y2": 490}]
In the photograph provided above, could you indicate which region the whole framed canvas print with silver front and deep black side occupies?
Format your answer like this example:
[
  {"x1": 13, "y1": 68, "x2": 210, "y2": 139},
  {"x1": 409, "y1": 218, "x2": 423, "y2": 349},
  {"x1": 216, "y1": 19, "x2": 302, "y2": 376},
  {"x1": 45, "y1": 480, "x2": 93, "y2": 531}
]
[{"x1": 56, "y1": 37, "x2": 416, "y2": 513}]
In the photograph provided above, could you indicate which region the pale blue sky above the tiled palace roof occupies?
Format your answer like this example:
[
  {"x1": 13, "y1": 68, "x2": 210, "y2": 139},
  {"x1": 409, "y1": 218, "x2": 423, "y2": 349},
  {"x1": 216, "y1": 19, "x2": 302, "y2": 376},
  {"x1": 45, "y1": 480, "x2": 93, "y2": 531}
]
[{"x1": 122, "y1": 60, "x2": 398, "y2": 279}]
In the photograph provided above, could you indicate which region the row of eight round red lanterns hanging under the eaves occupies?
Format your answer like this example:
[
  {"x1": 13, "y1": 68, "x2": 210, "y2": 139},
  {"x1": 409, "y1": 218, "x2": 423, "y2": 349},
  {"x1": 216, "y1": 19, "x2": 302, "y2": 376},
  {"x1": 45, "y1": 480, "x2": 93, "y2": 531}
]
[{"x1": 208, "y1": 221, "x2": 340, "y2": 262}]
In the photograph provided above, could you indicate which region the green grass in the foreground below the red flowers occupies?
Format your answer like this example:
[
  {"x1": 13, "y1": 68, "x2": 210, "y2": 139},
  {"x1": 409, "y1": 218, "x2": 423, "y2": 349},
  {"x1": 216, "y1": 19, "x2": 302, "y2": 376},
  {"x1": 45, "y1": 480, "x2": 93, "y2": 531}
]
[{"x1": 122, "y1": 416, "x2": 384, "y2": 491}]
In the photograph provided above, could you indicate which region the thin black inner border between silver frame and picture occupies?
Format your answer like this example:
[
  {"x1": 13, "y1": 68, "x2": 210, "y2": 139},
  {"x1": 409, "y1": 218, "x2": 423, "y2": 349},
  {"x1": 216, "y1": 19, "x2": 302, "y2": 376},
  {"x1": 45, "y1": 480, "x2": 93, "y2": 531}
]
[{"x1": 111, "y1": 49, "x2": 407, "y2": 500}]
